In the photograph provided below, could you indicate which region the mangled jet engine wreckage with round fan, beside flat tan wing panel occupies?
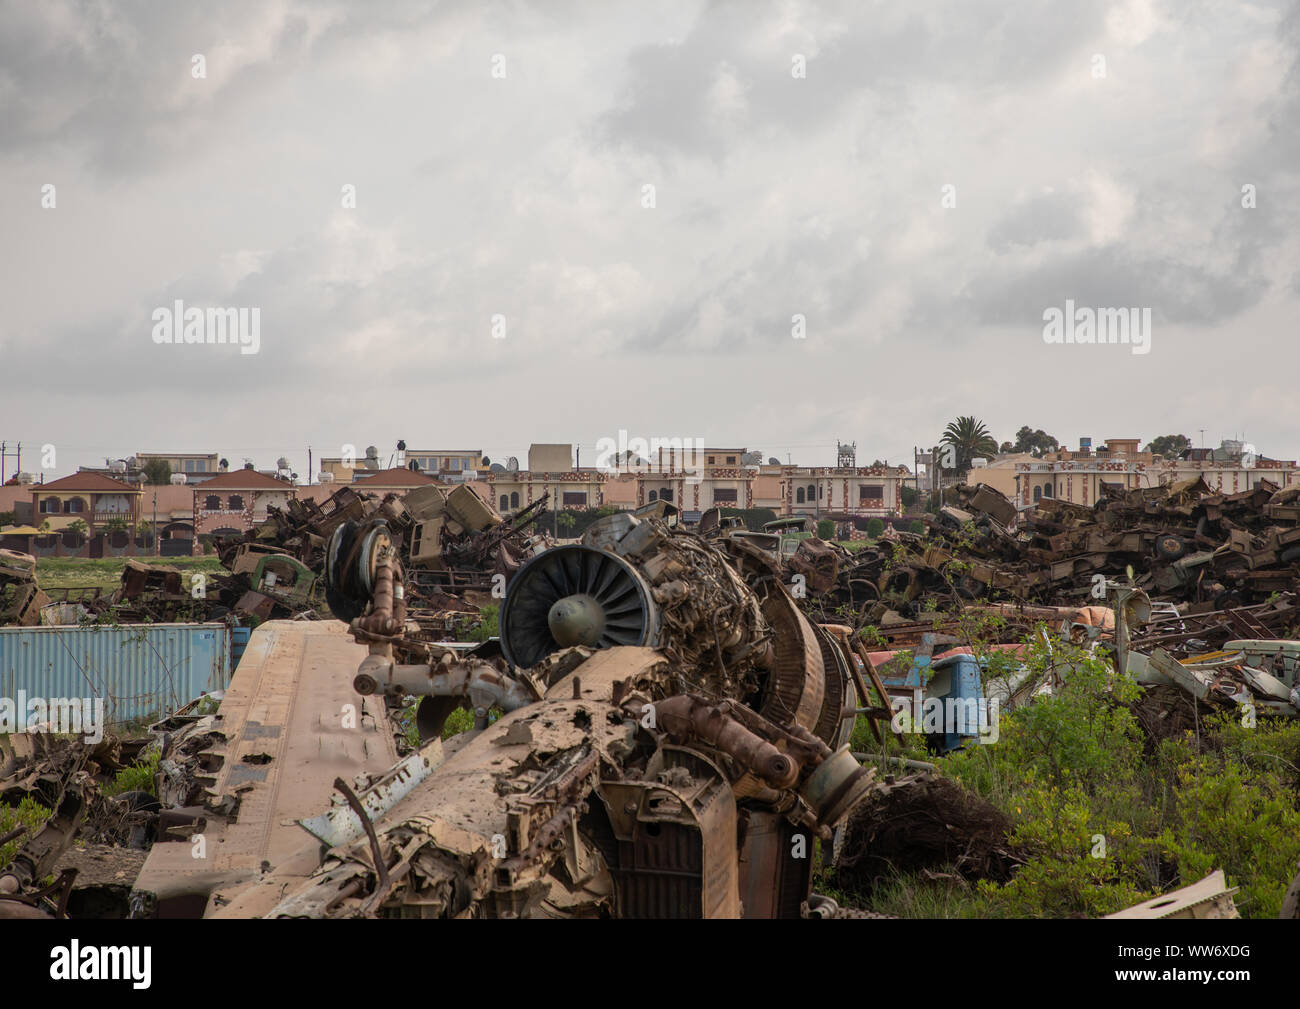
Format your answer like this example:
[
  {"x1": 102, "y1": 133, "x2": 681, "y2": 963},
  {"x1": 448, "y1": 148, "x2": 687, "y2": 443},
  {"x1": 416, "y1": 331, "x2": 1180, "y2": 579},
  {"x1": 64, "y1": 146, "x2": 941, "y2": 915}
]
[{"x1": 254, "y1": 514, "x2": 874, "y2": 918}]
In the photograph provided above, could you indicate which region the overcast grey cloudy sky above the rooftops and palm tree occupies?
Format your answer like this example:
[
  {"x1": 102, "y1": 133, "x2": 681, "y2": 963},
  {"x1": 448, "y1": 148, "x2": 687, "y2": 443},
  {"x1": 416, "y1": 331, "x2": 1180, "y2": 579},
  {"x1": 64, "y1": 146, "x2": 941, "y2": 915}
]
[{"x1": 0, "y1": 0, "x2": 1300, "y2": 478}]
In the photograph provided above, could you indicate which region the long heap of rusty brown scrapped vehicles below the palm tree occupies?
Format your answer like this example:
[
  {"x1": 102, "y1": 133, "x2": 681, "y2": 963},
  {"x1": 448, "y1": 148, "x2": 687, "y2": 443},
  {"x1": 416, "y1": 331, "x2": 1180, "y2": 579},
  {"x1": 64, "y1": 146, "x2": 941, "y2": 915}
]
[{"x1": 789, "y1": 480, "x2": 1300, "y2": 645}]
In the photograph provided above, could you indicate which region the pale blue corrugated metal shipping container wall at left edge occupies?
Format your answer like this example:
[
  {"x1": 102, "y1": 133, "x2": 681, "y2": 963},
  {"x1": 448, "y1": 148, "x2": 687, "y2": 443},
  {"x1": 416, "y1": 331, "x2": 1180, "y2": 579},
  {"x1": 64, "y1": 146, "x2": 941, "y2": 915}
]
[{"x1": 0, "y1": 624, "x2": 231, "y2": 726}]
